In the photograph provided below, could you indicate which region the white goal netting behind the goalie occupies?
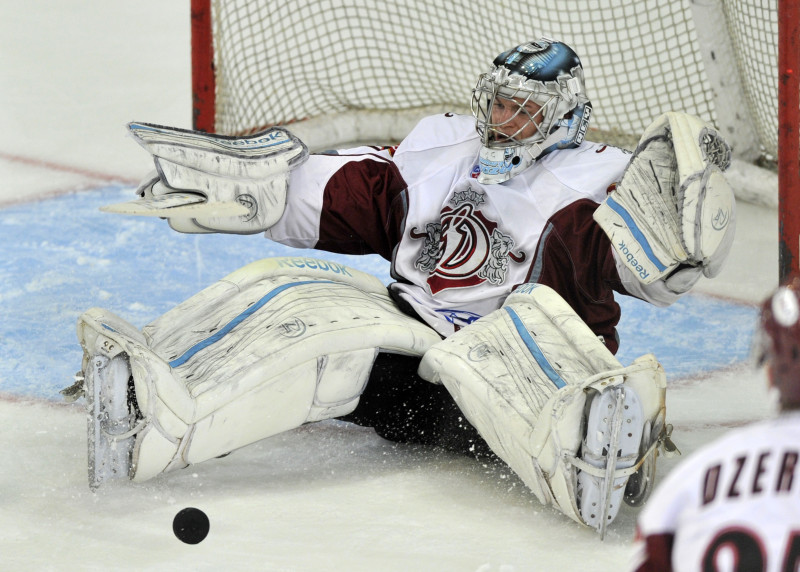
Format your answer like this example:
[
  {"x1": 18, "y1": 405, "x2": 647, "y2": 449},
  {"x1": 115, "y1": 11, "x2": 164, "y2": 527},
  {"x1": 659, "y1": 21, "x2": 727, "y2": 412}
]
[{"x1": 205, "y1": 0, "x2": 777, "y2": 159}]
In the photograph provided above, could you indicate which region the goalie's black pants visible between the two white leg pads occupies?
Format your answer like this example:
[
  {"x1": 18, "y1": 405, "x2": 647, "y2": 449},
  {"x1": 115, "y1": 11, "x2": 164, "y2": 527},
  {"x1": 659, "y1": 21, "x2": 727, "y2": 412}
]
[{"x1": 342, "y1": 353, "x2": 496, "y2": 460}]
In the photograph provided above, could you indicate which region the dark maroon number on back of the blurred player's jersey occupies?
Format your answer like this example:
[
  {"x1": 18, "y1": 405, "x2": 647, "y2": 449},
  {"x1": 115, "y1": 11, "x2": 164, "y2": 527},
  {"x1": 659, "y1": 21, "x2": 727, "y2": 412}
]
[{"x1": 703, "y1": 528, "x2": 800, "y2": 572}]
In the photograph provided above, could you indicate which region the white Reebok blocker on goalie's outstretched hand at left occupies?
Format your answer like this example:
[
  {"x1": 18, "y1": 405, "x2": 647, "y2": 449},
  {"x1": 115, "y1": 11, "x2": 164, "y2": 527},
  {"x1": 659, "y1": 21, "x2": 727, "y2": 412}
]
[{"x1": 101, "y1": 123, "x2": 308, "y2": 234}]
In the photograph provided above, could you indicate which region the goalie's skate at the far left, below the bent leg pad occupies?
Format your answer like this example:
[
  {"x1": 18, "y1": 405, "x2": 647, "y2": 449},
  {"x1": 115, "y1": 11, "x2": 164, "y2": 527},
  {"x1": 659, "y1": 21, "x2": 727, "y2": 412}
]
[{"x1": 84, "y1": 353, "x2": 142, "y2": 490}]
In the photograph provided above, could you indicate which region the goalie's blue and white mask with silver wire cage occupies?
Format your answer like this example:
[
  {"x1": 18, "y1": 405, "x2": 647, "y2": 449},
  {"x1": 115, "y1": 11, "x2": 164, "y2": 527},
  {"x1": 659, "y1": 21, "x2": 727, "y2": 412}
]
[{"x1": 471, "y1": 38, "x2": 592, "y2": 183}]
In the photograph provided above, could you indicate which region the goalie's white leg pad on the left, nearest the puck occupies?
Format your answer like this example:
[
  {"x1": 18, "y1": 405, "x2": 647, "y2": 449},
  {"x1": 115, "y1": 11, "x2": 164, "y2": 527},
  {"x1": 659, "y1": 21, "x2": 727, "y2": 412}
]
[{"x1": 78, "y1": 258, "x2": 441, "y2": 484}]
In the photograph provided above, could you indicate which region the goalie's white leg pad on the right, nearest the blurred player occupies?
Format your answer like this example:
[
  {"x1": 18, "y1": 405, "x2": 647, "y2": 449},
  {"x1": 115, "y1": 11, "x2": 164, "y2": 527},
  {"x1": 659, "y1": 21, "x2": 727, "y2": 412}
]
[{"x1": 419, "y1": 286, "x2": 666, "y2": 532}]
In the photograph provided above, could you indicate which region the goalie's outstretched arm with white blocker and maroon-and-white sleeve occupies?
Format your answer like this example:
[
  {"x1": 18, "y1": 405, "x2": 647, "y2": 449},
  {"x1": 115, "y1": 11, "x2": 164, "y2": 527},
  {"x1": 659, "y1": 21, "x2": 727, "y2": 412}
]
[{"x1": 104, "y1": 123, "x2": 404, "y2": 253}]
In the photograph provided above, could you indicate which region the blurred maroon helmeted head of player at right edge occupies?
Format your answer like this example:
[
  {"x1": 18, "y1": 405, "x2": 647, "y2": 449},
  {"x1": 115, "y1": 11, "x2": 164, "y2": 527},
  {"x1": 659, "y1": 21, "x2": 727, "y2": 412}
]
[{"x1": 753, "y1": 278, "x2": 800, "y2": 410}]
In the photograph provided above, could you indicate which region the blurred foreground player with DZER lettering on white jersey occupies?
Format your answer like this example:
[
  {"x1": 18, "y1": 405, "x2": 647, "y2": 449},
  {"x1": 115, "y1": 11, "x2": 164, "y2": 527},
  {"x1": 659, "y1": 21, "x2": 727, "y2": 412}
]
[{"x1": 636, "y1": 279, "x2": 800, "y2": 572}]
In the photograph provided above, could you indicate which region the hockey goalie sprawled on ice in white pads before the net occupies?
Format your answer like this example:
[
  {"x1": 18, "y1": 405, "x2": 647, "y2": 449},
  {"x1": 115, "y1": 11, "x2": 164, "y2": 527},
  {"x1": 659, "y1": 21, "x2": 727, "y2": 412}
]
[{"x1": 65, "y1": 38, "x2": 735, "y2": 533}]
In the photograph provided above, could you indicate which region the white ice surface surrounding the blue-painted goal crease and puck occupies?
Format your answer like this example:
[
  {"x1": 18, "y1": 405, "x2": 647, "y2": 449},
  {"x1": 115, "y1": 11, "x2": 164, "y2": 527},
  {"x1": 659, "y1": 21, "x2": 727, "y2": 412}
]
[{"x1": 0, "y1": 0, "x2": 778, "y2": 572}]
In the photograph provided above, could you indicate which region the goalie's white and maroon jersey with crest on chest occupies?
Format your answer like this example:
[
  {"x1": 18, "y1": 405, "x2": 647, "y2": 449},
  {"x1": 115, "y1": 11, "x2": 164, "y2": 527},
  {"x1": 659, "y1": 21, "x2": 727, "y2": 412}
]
[{"x1": 266, "y1": 113, "x2": 630, "y2": 344}]
